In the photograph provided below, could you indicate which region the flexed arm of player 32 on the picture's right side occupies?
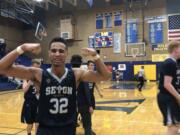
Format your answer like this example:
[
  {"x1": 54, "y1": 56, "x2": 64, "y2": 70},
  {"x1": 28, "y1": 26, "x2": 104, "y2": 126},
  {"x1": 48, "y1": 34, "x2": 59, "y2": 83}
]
[{"x1": 74, "y1": 48, "x2": 111, "y2": 83}]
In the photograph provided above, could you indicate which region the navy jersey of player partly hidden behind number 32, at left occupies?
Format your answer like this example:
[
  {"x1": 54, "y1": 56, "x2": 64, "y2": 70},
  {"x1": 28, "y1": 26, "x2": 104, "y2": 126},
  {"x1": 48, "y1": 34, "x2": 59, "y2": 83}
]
[{"x1": 24, "y1": 81, "x2": 37, "y2": 100}]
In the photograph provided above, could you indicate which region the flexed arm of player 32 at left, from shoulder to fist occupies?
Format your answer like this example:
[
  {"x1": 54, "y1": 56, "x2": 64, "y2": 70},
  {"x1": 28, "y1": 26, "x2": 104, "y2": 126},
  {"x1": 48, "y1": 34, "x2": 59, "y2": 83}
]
[{"x1": 0, "y1": 43, "x2": 42, "y2": 85}]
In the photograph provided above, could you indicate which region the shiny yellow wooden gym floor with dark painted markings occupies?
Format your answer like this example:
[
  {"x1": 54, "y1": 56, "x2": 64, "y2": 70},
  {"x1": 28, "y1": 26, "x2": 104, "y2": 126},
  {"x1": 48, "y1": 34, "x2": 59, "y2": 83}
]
[{"x1": 0, "y1": 82, "x2": 169, "y2": 135}]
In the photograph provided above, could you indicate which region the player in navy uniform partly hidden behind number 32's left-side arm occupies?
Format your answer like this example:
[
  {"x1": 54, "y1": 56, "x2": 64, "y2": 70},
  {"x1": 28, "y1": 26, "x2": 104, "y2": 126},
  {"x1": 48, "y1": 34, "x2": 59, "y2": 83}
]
[{"x1": 21, "y1": 59, "x2": 40, "y2": 135}]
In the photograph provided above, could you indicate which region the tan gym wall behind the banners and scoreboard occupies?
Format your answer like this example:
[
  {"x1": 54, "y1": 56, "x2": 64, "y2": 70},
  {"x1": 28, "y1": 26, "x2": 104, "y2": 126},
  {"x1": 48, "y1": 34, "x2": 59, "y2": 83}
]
[{"x1": 24, "y1": 0, "x2": 167, "y2": 63}]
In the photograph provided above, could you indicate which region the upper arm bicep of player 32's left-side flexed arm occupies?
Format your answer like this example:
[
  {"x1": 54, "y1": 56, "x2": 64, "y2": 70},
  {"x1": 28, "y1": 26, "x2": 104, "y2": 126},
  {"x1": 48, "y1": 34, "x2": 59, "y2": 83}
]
[{"x1": 4, "y1": 66, "x2": 35, "y2": 80}]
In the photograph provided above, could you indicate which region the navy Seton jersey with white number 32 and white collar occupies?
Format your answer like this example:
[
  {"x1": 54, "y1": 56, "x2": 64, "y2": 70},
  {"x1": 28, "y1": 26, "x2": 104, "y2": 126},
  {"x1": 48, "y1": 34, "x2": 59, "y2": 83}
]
[{"x1": 38, "y1": 68, "x2": 77, "y2": 127}]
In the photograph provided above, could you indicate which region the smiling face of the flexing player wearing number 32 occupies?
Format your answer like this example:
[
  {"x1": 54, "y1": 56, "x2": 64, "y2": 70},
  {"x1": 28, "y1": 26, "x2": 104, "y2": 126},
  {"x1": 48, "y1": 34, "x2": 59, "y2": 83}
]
[{"x1": 49, "y1": 42, "x2": 67, "y2": 67}]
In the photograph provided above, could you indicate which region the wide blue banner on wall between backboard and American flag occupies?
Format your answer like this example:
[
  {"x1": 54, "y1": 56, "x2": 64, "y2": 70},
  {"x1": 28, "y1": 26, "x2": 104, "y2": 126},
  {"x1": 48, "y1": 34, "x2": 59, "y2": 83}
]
[{"x1": 149, "y1": 22, "x2": 164, "y2": 44}]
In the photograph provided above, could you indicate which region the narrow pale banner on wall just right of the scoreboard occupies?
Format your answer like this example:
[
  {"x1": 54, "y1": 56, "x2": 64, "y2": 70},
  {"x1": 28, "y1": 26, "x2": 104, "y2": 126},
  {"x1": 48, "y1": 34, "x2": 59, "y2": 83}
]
[{"x1": 113, "y1": 33, "x2": 121, "y2": 53}]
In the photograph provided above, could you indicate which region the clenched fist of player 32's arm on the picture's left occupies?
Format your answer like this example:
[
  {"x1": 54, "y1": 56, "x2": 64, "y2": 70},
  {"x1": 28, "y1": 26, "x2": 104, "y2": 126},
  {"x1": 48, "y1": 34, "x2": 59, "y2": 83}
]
[{"x1": 21, "y1": 43, "x2": 41, "y2": 54}]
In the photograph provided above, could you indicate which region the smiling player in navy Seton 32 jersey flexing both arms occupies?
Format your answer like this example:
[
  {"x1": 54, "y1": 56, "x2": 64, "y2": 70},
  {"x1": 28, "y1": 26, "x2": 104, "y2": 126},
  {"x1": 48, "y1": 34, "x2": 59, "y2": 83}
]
[{"x1": 0, "y1": 37, "x2": 111, "y2": 135}]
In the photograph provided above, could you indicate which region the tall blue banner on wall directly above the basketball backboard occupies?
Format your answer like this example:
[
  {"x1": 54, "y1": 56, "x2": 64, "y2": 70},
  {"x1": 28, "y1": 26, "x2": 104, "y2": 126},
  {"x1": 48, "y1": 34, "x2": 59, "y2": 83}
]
[{"x1": 126, "y1": 19, "x2": 138, "y2": 43}]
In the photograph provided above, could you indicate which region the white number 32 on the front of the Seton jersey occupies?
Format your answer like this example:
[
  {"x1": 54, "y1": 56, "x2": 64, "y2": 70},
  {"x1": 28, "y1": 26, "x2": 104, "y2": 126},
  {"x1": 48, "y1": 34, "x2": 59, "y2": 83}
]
[{"x1": 49, "y1": 98, "x2": 68, "y2": 114}]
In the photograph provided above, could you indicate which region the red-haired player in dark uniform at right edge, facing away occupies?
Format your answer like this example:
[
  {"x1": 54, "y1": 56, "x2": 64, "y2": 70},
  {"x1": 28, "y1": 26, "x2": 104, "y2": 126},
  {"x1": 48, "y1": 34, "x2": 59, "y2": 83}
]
[{"x1": 158, "y1": 41, "x2": 180, "y2": 135}]
